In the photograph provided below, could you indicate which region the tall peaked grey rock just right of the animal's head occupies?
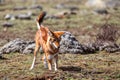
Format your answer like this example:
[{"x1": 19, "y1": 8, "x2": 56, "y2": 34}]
[{"x1": 59, "y1": 32, "x2": 87, "y2": 54}]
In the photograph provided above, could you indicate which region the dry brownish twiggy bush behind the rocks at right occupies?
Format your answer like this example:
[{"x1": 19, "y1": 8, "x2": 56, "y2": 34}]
[{"x1": 96, "y1": 24, "x2": 120, "y2": 43}]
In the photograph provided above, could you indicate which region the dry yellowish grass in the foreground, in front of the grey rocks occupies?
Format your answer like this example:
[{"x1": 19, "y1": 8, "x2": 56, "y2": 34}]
[{"x1": 0, "y1": 52, "x2": 120, "y2": 80}]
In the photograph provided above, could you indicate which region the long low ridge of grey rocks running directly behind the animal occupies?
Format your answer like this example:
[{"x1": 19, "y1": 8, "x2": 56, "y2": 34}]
[{"x1": 0, "y1": 32, "x2": 120, "y2": 54}]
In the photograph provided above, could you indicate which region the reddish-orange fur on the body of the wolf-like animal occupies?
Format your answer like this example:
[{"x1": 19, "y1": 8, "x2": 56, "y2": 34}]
[{"x1": 31, "y1": 11, "x2": 64, "y2": 70}]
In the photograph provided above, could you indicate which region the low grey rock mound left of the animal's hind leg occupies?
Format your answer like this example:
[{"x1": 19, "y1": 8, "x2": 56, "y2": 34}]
[{"x1": 0, "y1": 38, "x2": 34, "y2": 54}]
